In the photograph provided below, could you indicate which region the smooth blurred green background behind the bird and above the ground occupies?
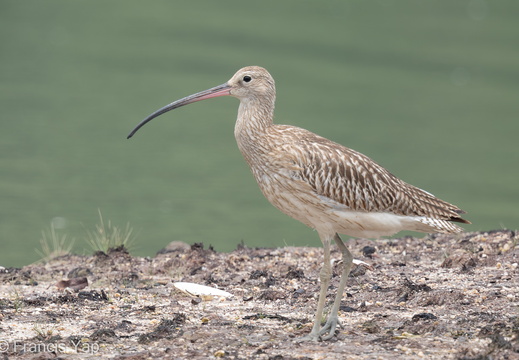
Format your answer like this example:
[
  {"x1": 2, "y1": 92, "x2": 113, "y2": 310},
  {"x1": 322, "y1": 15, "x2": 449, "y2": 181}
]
[{"x1": 0, "y1": 0, "x2": 519, "y2": 266}]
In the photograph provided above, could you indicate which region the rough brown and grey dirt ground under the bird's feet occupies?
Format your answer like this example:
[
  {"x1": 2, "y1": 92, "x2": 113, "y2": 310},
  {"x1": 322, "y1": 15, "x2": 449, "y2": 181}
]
[{"x1": 0, "y1": 230, "x2": 519, "y2": 360}]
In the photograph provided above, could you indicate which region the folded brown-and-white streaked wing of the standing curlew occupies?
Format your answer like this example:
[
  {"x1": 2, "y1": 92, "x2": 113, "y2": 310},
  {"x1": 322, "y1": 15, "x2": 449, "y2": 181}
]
[{"x1": 285, "y1": 129, "x2": 468, "y2": 223}]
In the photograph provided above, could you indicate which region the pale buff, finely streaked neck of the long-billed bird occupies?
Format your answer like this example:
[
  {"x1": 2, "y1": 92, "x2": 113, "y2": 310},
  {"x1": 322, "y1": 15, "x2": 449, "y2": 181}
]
[{"x1": 234, "y1": 99, "x2": 274, "y2": 162}]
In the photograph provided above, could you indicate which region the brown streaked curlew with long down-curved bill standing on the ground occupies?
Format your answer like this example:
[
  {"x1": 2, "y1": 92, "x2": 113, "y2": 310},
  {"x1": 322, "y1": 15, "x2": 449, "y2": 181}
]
[{"x1": 127, "y1": 66, "x2": 470, "y2": 341}]
